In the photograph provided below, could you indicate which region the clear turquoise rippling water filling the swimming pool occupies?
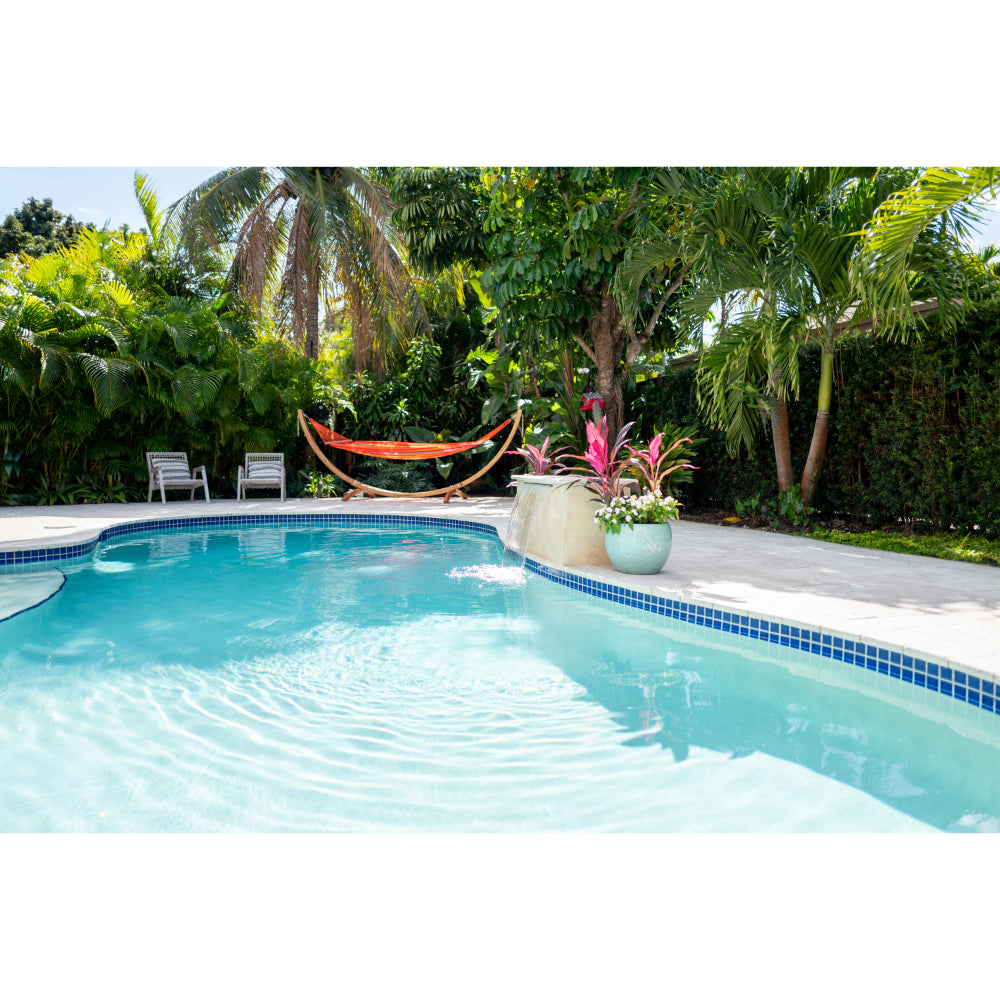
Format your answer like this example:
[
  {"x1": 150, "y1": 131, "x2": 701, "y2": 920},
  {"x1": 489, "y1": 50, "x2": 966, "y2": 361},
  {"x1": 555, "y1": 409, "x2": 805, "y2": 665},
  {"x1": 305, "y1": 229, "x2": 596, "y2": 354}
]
[{"x1": 0, "y1": 526, "x2": 1000, "y2": 832}]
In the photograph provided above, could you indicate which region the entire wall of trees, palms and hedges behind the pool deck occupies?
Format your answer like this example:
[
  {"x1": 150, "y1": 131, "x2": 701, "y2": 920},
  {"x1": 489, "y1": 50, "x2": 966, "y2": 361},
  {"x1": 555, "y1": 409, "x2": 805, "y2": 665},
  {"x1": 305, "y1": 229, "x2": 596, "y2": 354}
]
[{"x1": 0, "y1": 167, "x2": 1000, "y2": 531}]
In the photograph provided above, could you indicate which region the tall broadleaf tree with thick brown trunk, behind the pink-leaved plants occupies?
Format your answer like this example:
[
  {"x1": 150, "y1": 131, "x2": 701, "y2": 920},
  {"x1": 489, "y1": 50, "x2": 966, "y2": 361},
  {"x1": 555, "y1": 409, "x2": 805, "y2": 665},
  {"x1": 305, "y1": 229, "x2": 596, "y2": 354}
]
[{"x1": 474, "y1": 167, "x2": 683, "y2": 435}]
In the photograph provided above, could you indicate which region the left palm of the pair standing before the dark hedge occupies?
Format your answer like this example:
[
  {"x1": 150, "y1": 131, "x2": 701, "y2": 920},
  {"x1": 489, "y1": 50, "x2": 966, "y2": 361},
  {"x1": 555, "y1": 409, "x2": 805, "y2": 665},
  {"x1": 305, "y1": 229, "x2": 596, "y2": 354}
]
[{"x1": 616, "y1": 168, "x2": 812, "y2": 490}]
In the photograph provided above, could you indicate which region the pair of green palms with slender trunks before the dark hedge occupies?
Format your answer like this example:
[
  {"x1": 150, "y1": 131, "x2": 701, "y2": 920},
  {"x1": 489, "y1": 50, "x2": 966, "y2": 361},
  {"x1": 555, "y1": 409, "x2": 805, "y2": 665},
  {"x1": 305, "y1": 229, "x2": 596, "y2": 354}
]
[{"x1": 619, "y1": 168, "x2": 986, "y2": 503}]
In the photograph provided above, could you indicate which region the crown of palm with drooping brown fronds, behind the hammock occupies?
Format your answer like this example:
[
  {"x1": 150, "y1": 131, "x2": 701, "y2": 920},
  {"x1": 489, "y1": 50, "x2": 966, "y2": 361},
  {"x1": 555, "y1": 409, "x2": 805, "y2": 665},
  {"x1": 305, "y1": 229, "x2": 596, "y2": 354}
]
[{"x1": 170, "y1": 167, "x2": 426, "y2": 372}]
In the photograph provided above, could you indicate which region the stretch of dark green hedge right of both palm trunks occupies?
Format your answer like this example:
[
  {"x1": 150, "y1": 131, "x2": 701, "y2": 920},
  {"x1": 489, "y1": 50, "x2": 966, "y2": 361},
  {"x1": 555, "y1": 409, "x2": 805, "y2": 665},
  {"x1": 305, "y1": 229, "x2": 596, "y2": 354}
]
[{"x1": 824, "y1": 306, "x2": 1000, "y2": 535}]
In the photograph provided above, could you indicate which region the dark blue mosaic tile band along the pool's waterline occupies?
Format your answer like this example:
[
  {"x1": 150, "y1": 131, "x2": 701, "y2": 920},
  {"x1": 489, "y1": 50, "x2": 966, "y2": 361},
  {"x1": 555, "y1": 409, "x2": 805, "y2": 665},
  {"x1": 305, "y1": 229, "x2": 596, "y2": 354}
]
[{"x1": 0, "y1": 514, "x2": 1000, "y2": 715}]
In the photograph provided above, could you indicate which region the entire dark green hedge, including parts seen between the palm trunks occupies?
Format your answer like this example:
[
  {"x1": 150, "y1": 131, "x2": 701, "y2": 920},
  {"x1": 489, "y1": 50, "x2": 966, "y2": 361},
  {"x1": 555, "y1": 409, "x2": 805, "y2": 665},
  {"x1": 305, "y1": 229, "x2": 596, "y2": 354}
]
[{"x1": 630, "y1": 303, "x2": 1000, "y2": 537}]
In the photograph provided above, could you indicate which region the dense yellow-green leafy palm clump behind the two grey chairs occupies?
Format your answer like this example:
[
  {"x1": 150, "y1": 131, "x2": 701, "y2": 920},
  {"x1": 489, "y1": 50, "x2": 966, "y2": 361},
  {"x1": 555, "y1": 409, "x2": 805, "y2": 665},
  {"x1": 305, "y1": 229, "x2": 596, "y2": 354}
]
[{"x1": 0, "y1": 177, "x2": 312, "y2": 500}]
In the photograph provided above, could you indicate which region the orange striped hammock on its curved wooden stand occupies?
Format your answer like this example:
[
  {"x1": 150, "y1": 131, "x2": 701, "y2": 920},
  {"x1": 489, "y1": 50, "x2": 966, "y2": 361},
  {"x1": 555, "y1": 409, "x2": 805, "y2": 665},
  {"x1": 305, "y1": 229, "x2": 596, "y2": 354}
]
[{"x1": 298, "y1": 410, "x2": 521, "y2": 503}]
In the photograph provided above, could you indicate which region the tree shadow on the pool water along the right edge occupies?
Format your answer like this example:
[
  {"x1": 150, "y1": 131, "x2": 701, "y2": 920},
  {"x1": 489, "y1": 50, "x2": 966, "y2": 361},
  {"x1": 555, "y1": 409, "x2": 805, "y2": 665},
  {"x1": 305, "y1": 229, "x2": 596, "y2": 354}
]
[{"x1": 526, "y1": 595, "x2": 1000, "y2": 830}]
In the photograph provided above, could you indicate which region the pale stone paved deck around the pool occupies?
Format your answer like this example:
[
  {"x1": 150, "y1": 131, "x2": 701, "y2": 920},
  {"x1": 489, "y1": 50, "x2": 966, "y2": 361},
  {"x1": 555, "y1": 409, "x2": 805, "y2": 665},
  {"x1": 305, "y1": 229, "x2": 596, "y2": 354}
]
[{"x1": 0, "y1": 497, "x2": 1000, "y2": 676}]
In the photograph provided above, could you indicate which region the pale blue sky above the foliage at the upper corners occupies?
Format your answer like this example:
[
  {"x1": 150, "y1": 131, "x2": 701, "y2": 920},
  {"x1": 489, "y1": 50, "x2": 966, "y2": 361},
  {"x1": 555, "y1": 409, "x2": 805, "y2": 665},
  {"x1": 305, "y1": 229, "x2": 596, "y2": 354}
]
[{"x1": 0, "y1": 166, "x2": 1000, "y2": 246}]
